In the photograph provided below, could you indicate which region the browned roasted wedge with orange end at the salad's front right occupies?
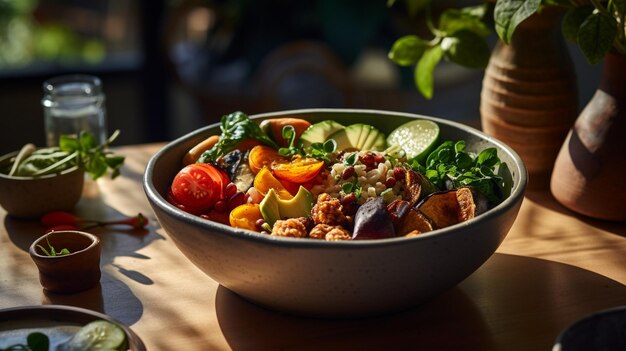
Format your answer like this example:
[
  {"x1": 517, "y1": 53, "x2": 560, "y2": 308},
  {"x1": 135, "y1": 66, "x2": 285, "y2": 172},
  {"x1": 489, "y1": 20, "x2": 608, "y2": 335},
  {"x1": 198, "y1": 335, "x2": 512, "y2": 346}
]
[{"x1": 417, "y1": 188, "x2": 476, "y2": 229}]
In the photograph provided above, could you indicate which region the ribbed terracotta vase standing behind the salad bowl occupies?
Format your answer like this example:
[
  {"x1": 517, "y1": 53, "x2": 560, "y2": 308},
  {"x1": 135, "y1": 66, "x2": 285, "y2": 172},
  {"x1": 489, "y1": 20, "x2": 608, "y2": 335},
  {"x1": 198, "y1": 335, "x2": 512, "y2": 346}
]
[{"x1": 480, "y1": 7, "x2": 578, "y2": 189}]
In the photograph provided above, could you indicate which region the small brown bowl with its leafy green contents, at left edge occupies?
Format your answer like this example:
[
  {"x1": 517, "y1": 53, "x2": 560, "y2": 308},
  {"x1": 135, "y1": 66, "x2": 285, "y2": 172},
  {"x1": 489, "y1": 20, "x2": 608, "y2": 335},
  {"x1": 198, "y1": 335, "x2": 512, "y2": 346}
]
[{"x1": 0, "y1": 131, "x2": 124, "y2": 218}]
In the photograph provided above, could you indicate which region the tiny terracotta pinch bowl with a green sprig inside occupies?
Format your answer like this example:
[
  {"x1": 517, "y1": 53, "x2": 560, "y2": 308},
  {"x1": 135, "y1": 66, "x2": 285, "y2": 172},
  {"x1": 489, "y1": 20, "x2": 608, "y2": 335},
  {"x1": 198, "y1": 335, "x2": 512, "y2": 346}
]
[{"x1": 29, "y1": 230, "x2": 101, "y2": 293}]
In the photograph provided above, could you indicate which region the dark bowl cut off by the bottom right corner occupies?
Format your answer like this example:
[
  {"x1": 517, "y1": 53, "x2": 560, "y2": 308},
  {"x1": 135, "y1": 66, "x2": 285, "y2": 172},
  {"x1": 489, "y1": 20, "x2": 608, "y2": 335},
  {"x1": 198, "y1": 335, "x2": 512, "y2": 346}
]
[{"x1": 552, "y1": 306, "x2": 626, "y2": 351}]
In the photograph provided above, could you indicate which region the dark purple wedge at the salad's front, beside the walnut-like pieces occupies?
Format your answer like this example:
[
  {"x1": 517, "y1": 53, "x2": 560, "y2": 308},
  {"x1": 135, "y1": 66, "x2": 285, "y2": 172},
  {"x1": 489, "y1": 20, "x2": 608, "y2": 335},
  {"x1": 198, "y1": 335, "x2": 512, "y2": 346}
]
[{"x1": 352, "y1": 197, "x2": 396, "y2": 240}]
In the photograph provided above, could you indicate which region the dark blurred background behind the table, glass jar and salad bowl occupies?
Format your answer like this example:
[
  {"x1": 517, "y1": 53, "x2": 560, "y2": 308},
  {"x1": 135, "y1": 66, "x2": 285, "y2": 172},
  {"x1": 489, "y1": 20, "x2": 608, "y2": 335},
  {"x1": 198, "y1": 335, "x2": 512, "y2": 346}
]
[{"x1": 0, "y1": 0, "x2": 600, "y2": 153}]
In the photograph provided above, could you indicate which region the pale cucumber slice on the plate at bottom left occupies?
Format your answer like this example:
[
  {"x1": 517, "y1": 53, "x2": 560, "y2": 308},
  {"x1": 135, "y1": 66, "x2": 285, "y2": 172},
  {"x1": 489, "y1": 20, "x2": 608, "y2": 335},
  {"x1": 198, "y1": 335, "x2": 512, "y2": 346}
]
[{"x1": 58, "y1": 320, "x2": 127, "y2": 351}]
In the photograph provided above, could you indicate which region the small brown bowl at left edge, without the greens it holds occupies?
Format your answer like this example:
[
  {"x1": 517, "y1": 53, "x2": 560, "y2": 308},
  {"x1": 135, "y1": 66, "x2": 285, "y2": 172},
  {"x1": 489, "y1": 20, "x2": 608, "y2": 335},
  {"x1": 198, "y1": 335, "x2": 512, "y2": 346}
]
[{"x1": 0, "y1": 152, "x2": 84, "y2": 218}]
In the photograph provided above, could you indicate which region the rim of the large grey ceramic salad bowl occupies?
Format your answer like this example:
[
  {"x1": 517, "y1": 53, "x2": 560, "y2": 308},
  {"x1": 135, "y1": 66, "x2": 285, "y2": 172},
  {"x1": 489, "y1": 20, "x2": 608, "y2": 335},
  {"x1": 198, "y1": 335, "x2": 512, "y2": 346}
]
[{"x1": 142, "y1": 108, "x2": 528, "y2": 249}]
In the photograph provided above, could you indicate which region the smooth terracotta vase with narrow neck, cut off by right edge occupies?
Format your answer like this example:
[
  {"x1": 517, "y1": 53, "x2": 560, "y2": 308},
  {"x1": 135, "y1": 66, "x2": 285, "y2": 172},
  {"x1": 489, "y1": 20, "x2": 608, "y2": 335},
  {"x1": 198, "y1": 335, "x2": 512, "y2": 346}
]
[{"x1": 550, "y1": 53, "x2": 626, "y2": 221}]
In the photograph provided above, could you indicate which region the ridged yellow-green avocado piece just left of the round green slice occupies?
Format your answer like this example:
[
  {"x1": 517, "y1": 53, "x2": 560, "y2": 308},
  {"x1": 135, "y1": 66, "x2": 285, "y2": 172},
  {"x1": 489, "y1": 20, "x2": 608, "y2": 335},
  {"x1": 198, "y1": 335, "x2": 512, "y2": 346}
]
[{"x1": 329, "y1": 123, "x2": 385, "y2": 150}]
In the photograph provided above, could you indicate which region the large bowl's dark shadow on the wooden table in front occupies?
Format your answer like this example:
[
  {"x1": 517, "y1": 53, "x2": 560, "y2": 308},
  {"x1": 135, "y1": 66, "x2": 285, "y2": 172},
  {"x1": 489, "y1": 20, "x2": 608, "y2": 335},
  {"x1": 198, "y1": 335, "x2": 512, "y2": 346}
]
[{"x1": 216, "y1": 254, "x2": 626, "y2": 350}]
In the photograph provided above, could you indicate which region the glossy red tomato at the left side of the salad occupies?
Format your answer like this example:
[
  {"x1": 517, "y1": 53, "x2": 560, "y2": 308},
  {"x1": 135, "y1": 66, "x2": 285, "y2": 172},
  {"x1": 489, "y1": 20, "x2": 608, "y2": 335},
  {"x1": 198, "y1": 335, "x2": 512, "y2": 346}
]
[{"x1": 171, "y1": 163, "x2": 229, "y2": 213}]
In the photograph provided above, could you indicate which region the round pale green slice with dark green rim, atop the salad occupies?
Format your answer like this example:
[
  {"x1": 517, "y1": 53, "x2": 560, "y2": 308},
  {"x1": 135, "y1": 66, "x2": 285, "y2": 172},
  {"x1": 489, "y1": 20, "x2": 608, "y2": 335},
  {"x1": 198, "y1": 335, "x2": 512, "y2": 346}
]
[{"x1": 387, "y1": 119, "x2": 439, "y2": 160}]
